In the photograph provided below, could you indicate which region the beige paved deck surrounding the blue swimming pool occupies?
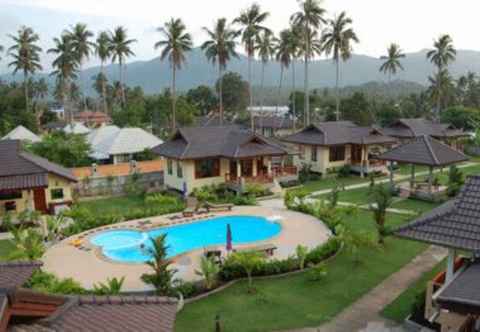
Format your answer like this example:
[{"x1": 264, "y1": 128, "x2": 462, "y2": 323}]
[{"x1": 42, "y1": 206, "x2": 331, "y2": 292}]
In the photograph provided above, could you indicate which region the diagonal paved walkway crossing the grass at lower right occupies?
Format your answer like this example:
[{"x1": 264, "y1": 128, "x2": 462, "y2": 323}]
[{"x1": 285, "y1": 246, "x2": 447, "y2": 332}]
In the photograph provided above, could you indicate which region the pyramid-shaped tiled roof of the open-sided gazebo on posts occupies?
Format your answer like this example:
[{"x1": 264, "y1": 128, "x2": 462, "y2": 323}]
[{"x1": 376, "y1": 135, "x2": 468, "y2": 167}]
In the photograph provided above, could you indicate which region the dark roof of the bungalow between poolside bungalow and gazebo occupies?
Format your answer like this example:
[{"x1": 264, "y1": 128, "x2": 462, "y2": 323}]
[{"x1": 282, "y1": 121, "x2": 395, "y2": 146}]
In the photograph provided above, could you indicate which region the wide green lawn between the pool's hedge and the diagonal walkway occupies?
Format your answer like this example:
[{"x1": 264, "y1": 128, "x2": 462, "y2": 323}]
[{"x1": 176, "y1": 211, "x2": 426, "y2": 332}]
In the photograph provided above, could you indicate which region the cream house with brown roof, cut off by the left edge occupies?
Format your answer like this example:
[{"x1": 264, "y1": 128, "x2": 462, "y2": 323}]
[{"x1": 0, "y1": 140, "x2": 77, "y2": 215}]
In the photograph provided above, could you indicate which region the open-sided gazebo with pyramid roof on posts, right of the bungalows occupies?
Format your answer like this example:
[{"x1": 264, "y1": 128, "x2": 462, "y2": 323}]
[{"x1": 377, "y1": 135, "x2": 468, "y2": 199}]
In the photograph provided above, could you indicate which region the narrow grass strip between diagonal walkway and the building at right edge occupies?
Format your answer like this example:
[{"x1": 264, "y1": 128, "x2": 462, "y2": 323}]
[{"x1": 381, "y1": 262, "x2": 445, "y2": 323}]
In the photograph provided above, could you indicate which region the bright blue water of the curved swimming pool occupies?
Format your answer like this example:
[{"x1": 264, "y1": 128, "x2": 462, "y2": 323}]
[{"x1": 90, "y1": 216, "x2": 281, "y2": 263}]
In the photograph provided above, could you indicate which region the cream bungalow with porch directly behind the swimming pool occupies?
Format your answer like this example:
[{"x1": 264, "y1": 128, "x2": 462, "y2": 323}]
[{"x1": 153, "y1": 126, "x2": 296, "y2": 194}]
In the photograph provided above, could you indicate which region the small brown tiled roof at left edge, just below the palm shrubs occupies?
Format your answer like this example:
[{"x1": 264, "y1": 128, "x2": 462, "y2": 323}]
[{"x1": 0, "y1": 261, "x2": 43, "y2": 289}]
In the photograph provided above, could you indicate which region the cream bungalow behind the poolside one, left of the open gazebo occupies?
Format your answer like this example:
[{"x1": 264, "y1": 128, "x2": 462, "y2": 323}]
[{"x1": 282, "y1": 121, "x2": 396, "y2": 176}]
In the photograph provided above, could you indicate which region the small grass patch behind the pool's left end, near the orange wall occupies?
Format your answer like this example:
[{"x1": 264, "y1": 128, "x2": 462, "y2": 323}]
[{"x1": 77, "y1": 196, "x2": 145, "y2": 214}]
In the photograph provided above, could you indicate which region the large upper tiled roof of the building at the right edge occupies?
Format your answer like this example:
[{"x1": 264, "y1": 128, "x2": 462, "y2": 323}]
[{"x1": 394, "y1": 176, "x2": 480, "y2": 252}]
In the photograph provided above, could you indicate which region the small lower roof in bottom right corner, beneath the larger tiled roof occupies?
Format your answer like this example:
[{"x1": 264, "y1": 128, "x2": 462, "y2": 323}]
[{"x1": 436, "y1": 260, "x2": 480, "y2": 314}]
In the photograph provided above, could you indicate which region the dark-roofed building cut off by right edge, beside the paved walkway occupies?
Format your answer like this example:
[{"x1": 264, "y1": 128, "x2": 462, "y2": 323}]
[{"x1": 394, "y1": 175, "x2": 480, "y2": 331}]
